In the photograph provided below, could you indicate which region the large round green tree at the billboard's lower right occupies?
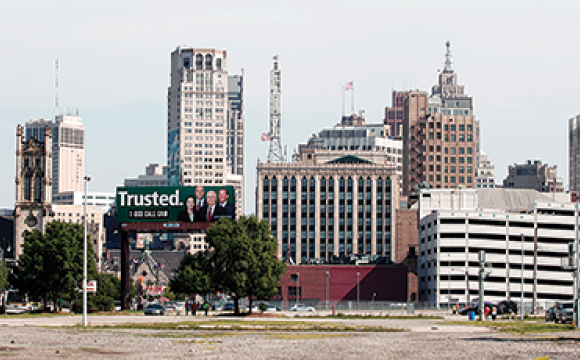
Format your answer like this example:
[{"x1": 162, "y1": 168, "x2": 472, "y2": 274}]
[{"x1": 205, "y1": 216, "x2": 286, "y2": 313}]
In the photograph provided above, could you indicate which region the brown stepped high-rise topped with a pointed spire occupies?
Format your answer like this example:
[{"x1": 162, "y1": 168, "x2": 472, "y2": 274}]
[{"x1": 403, "y1": 42, "x2": 479, "y2": 195}]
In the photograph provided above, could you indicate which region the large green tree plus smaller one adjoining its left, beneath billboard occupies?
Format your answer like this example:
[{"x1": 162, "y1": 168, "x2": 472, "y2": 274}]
[{"x1": 169, "y1": 216, "x2": 286, "y2": 313}]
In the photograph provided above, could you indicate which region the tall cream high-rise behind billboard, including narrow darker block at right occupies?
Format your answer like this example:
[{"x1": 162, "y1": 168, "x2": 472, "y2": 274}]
[{"x1": 167, "y1": 46, "x2": 244, "y2": 214}]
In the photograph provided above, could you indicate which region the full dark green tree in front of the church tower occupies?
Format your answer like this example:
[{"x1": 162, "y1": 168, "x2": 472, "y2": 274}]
[{"x1": 17, "y1": 221, "x2": 97, "y2": 311}]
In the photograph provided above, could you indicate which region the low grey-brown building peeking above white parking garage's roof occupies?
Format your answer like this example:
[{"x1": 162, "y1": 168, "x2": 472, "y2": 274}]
[{"x1": 503, "y1": 160, "x2": 564, "y2": 193}]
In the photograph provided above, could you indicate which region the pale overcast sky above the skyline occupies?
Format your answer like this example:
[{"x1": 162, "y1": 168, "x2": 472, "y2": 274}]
[{"x1": 0, "y1": 0, "x2": 580, "y2": 213}]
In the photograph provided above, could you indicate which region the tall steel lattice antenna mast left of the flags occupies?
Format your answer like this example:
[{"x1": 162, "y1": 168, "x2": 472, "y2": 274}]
[{"x1": 268, "y1": 55, "x2": 285, "y2": 163}]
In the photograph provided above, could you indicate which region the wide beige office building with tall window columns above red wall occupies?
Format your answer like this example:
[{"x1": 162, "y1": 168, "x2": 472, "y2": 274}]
[{"x1": 256, "y1": 116, "x2": 399, "y2": 264}]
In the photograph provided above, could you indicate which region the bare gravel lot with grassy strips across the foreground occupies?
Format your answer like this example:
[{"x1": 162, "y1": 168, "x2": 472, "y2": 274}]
[{"x1": 0, "y1": 316, "x2": 580, "y2": 360}]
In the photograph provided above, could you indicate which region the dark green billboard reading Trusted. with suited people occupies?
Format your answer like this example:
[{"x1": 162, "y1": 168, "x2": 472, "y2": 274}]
[{"x1": 117, "y1": 185, "x2": 236, "y2": 223}]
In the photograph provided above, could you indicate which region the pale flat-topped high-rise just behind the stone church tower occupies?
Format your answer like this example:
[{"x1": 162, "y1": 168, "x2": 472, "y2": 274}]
[{"x1": 25, "y1": 112, "x2": 85, "y2": 196}]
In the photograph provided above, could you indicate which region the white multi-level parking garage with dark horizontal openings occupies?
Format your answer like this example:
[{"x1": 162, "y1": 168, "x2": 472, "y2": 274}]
[{"x1": 419, "y1": 189, "x2": 578, "y2": 309}]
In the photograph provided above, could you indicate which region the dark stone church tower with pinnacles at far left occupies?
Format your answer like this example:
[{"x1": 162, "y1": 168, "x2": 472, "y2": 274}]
[{"x1": 14, "y1": 125, "x2": 53, "y2": 260}]
